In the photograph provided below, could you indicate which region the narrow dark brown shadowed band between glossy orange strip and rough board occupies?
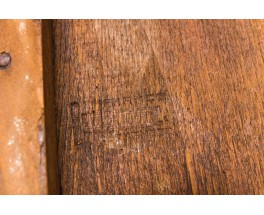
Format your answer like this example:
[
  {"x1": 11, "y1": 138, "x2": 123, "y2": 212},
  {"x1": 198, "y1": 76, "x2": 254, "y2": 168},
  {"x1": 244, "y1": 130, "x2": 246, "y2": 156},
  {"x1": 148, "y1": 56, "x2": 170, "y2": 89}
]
[{"x1": 41, "y1": 20, "x2": 60, "y2": 194}]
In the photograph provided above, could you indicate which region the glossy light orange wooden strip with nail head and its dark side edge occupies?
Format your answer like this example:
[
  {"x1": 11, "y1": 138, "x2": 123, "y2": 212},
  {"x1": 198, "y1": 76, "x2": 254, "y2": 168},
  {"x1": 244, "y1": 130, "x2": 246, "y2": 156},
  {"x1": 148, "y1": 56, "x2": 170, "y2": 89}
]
[{"x1": 0, "y1": 20, "x2": 58, "y2": 194}]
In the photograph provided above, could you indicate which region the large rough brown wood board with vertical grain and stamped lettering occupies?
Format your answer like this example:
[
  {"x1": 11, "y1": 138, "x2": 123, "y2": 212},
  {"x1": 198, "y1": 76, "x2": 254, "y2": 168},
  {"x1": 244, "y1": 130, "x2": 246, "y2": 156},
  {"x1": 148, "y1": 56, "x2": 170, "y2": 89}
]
[{"x1": 53, "y1": 20, "x2": 264, "y2": 194}]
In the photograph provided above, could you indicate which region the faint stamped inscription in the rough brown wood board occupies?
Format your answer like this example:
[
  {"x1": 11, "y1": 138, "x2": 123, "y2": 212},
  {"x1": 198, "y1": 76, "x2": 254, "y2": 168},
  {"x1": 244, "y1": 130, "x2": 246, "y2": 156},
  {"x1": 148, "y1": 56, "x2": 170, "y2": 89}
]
[{"x1": 70, "y1": 91, "x2": 172, "y2": 148}]
